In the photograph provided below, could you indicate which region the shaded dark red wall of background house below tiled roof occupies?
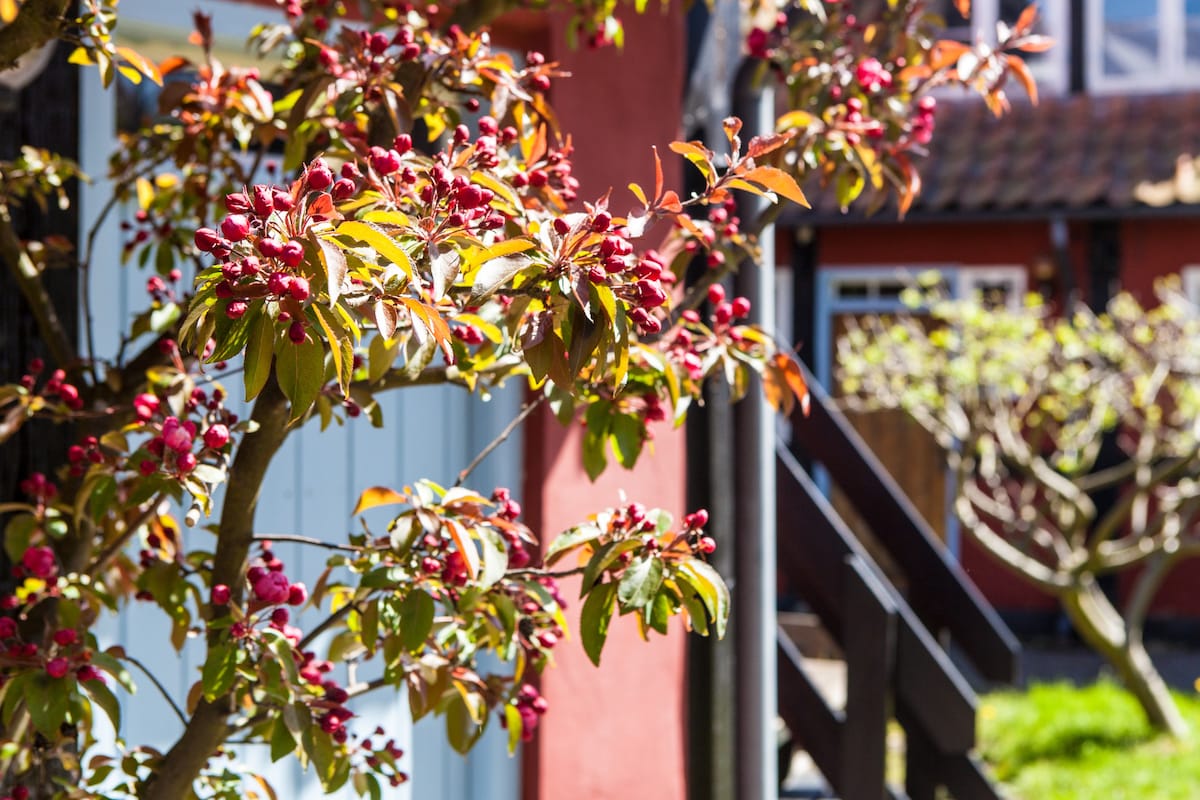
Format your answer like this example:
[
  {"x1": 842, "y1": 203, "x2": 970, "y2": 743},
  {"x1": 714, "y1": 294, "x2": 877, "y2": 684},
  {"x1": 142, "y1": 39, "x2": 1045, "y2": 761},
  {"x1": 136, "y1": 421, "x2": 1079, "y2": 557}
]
[{"x1": 818, "y1": 218, "x2": 1200, "y2": 616}]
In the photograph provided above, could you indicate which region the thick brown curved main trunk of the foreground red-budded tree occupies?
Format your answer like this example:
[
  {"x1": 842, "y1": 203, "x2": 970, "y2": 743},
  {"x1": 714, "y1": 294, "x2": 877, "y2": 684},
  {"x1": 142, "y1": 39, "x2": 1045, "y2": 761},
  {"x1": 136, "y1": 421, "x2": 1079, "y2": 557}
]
[{"x1": 142, "y1": 378, "x2": 288, "y2": 800}]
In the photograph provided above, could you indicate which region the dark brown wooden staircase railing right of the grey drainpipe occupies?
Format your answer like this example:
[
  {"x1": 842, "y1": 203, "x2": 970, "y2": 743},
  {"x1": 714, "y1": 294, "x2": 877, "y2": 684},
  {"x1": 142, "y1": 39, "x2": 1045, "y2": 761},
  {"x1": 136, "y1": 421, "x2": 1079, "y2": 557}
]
[{"x1": 776, "y1": 375, "x2": 1019, "y2": 800}]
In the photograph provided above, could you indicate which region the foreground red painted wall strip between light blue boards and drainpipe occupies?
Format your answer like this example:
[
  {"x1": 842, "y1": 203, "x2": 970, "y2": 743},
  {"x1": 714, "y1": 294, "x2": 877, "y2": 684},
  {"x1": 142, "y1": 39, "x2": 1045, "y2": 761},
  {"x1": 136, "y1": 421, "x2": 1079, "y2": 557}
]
[{"x1": 523, "y1": 5, "x2": 686, "y2": 800}]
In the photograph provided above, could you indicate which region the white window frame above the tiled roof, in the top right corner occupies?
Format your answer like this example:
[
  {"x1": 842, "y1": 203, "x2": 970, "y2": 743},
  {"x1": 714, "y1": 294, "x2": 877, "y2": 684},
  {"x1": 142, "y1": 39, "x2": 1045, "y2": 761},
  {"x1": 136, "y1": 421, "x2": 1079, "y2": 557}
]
[{"x1": 1094, "y1": 0, "x2": 1200, "y2": 94}]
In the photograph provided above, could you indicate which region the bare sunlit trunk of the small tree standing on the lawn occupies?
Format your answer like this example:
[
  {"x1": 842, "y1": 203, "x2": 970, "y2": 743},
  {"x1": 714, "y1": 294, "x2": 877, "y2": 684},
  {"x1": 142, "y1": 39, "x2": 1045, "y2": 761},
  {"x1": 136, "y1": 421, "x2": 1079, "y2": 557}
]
[{"x1": 1060, "y1": 576, "x2": 1189, "y2": 739}]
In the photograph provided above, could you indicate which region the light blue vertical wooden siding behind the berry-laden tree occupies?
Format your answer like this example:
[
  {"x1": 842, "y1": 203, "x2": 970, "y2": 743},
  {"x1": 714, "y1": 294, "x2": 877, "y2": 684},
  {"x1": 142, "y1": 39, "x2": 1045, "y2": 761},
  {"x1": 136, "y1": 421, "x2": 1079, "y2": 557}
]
[{"x1": 80, "y1": 0, "x2": 522, "y2": 800}]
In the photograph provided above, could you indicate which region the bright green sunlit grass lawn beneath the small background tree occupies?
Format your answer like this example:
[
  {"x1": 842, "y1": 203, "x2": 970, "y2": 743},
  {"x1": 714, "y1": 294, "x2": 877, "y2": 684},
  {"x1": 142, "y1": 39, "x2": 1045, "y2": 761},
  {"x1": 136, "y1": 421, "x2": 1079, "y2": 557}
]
[{"x1": 979, "y1": 682, "x2": 1200, "y2": 800}]
